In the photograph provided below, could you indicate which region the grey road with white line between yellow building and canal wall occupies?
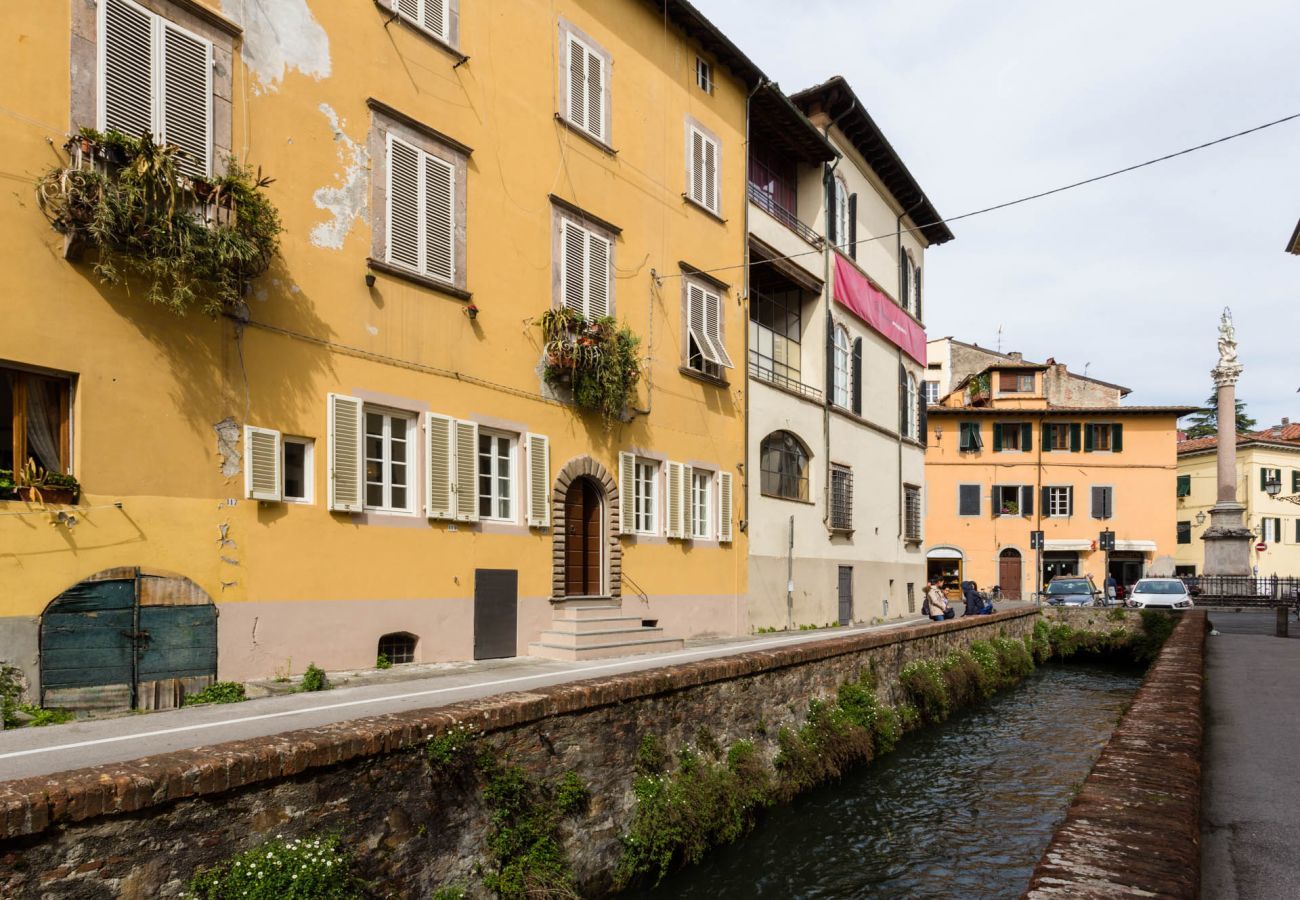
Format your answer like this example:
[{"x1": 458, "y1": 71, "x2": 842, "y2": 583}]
[{"x1": 0, "y1": 603, "x2": 1027, "y2": 782}]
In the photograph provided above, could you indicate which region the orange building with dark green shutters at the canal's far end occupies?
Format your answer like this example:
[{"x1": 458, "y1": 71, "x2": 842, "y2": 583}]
[{"x1": 926, "y1": 356, "x2": 1188, "y2": 600}]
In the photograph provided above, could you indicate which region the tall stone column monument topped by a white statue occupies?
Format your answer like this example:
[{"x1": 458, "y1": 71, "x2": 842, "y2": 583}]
[{"x1": 1201, "y1": 307, "x2": 1255, "y2": 576}]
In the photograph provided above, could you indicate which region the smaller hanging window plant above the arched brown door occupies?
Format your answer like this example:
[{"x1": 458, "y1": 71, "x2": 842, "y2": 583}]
[{"x1": 540, "y1": 307, "x2": 641, "y2": 428}]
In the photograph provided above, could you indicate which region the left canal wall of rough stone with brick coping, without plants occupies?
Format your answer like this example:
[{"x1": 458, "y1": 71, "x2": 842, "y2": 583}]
[{"x1": 0, "y1": 609, "x2": 1037, "y2": 899}]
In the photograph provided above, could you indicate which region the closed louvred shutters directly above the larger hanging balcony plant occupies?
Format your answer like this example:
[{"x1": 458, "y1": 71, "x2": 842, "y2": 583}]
[{"x1": 96, "y1": 0, "x2": 212, "y2": 176}]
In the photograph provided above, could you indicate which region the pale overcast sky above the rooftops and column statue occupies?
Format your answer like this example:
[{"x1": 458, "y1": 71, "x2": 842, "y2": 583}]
[{"x1": 697, "y1": 0, "x2": 1300, "y2": 427}]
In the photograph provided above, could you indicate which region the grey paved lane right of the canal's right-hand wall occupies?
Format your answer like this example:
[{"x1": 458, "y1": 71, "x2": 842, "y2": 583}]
[{"x1": 1201, "y1": 611, "x2": 1300, "y2": 900}]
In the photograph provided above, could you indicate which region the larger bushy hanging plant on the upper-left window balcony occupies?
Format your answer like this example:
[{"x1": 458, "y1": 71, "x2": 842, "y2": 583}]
[{"x1": 36, "y1": 129, "x2": 281, "y2": 316}]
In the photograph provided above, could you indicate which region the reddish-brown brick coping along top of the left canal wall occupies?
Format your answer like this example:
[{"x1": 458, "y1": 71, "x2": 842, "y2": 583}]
[{"x1": 0, "y1": 607, "x2": 1039, "y2": 840}]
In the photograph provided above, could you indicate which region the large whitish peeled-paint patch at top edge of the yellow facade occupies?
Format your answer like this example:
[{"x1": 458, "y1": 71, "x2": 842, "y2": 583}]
[{"x1": 221, "y1": 0, "x2": 330, "y2": 94}]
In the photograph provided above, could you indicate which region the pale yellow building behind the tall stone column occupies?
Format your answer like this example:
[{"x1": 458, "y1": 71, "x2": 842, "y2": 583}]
[{"x1": 1177, "y1": 420, "x2": 1300, "y2": 576}]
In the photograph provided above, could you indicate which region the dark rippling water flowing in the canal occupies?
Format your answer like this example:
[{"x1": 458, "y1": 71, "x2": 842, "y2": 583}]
[{"x1": 642, "y1": 665, "x2": 1141, "y2": 900}]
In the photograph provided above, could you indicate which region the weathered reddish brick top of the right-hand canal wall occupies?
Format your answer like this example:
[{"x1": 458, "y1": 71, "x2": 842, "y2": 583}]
[{"x1": 1024, "y1": 610, "x2": 1206, "y2": 900}]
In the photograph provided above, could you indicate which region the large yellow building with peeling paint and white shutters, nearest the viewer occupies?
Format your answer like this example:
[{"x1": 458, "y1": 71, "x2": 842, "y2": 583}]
[{"x1": 0, "y1": 0, "x2": 759, "y2": 705}]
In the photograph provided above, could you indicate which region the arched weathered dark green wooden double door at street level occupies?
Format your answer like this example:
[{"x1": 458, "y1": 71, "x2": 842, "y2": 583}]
[{"x1": 40, "y1": 568, "x2": 217, "y2": 711}]
